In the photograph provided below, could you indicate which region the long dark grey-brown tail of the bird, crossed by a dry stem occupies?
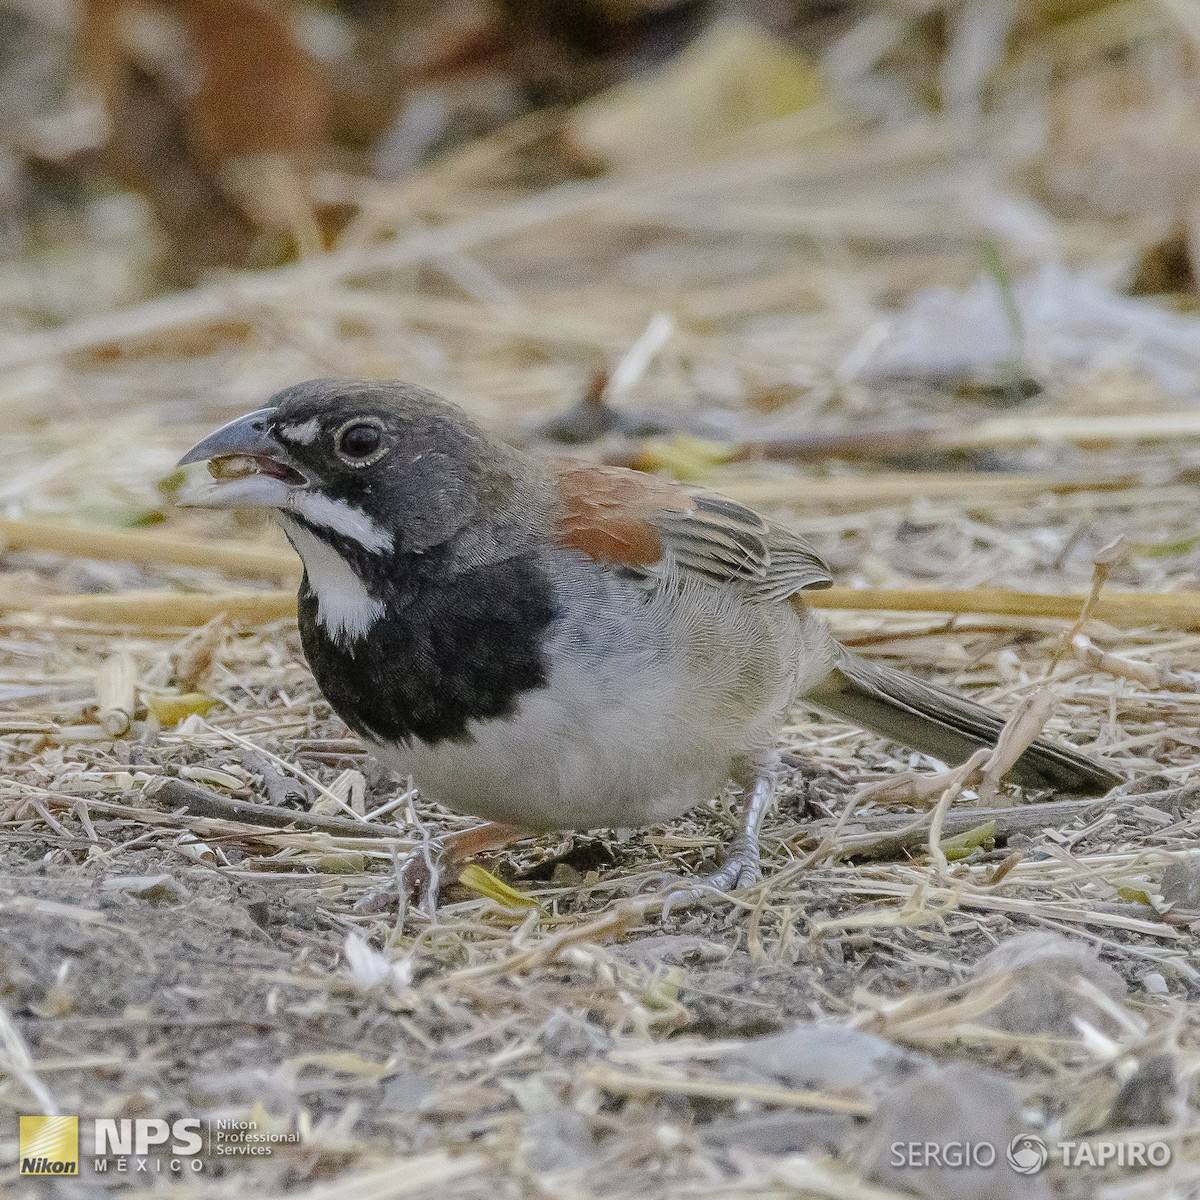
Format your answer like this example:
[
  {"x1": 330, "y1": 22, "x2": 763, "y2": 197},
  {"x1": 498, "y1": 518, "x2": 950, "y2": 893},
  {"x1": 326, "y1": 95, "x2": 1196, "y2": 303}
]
[{"x1": 805, "y1": 648, "x2": 1123, "y2": 796}]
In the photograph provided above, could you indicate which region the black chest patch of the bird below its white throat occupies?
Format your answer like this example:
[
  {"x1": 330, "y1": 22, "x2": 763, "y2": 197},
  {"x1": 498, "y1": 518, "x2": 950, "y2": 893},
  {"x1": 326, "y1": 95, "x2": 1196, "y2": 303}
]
[{"x1": 300, "y1": 550, "x2": 554, "y2": 744}]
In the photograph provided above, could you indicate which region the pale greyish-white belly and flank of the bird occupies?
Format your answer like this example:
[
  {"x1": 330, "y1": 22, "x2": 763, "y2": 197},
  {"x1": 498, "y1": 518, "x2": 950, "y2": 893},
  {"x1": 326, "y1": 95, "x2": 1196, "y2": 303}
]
[{"x1": 376, "y1": 568, "x2": 828, "y2": 830}]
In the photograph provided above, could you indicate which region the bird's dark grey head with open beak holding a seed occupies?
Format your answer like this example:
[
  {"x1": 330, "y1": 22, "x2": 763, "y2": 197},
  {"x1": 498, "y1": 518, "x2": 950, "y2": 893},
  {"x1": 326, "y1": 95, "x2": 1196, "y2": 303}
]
[{"x1": 180, "y1": 379, "x2": 496, "y2": 558}]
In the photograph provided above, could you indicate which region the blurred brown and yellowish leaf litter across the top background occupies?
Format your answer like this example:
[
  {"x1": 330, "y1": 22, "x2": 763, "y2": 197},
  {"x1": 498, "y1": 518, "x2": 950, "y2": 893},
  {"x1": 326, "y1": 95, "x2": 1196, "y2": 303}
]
[{"x1": 0, "y1": 0, "x2": 1200, "y2": 307}]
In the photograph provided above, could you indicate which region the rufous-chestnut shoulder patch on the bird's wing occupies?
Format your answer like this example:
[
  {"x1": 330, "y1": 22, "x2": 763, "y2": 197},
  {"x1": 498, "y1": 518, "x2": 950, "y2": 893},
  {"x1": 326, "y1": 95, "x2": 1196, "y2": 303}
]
[{"x1": 557, "y1": 461, "x2": 695, "y2": 566}]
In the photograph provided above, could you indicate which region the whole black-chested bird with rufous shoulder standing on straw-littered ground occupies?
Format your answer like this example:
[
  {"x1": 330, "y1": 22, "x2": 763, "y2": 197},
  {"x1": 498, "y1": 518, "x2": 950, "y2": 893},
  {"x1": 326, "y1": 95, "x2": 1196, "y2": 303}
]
[{"x1": 180, "y1": 379, "x2": 1121, "y2": 901}]
